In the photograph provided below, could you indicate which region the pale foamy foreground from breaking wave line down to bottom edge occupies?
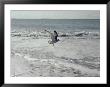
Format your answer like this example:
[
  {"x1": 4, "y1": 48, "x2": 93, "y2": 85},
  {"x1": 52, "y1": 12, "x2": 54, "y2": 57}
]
[{"x1": 10, "y1": 30, "x2": 100, "y2": 77}]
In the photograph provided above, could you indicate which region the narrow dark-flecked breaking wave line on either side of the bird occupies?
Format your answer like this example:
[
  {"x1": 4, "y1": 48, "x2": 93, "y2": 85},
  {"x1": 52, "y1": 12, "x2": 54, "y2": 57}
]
[{"x1": 11, "y1": 31, "x2": 100, "y2": 38}]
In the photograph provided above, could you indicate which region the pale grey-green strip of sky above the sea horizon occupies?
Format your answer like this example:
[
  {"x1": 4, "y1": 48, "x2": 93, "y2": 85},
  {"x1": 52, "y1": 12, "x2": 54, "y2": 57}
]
[{"x1": 11, "y1": 10, "x2": 100, "y2": 19}]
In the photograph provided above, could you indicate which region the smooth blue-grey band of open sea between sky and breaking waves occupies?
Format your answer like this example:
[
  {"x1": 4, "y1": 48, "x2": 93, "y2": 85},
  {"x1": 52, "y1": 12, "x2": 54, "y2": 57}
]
[{"x1": 11, "y1": 19, "x2": 100, "y2": 32}]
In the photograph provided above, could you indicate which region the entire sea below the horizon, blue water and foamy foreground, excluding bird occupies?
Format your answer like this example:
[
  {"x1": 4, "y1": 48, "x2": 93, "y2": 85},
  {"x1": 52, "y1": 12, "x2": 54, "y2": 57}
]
[{"x1": 10, "y1": 19, "x2": 100, "y2": 77}]
